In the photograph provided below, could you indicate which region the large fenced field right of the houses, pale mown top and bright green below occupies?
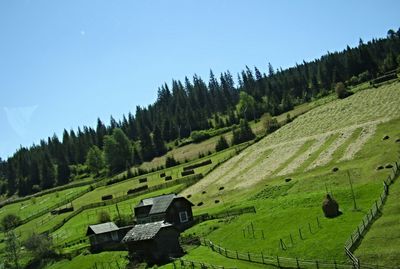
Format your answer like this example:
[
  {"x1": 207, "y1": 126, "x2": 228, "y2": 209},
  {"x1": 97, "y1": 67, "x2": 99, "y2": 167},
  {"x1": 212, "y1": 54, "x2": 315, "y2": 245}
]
[{"x1": 170, "y1": 83, "x2": 400, "y2": 265}]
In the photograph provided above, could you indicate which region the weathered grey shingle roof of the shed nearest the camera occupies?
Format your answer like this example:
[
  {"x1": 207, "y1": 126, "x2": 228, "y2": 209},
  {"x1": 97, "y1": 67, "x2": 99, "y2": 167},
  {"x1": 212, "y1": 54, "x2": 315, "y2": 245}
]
[{"x1": 122, "y1": 221, "x2": 173, "y2": 243}]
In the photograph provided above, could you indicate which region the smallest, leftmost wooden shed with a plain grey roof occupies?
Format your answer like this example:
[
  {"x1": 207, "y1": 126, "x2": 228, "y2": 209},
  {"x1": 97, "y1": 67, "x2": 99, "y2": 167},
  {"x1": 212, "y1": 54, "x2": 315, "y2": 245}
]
[{"x1": 86, "y1": 222, "x2": 132, "y2": 252}]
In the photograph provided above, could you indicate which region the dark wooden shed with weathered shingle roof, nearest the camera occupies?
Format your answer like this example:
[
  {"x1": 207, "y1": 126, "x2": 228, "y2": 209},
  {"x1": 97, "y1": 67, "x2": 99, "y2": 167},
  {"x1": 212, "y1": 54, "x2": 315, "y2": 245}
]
[{"x1": 122, "y1": 221, "x2": 183, "y2": 264}]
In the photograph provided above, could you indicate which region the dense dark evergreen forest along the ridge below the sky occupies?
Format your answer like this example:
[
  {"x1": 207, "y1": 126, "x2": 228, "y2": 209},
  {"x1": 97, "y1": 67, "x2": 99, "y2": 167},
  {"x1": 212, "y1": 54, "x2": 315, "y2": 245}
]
[{"x1": 0, "y1": 29, "x2": 400, "y2": 196}]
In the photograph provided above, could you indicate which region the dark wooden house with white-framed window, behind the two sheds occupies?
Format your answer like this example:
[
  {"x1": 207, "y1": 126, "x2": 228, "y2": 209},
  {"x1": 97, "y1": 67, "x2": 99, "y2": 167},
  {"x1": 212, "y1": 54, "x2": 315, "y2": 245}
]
[{"x1": 135, "y1": 194, "x2": 193, "y2": 231}]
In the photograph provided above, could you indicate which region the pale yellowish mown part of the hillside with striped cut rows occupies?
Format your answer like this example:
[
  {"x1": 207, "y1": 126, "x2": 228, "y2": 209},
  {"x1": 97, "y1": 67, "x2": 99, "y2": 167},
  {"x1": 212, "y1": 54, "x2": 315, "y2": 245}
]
[{"x1": 182, "y1": 83, "x2": 400, "y2": 201}]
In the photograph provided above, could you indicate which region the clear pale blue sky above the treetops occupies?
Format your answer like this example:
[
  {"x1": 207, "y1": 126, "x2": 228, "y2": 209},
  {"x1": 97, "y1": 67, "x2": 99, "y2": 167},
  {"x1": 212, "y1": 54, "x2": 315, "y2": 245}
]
[{"x1": 0, "y1": 0, "x2": 400, "y2": 159}]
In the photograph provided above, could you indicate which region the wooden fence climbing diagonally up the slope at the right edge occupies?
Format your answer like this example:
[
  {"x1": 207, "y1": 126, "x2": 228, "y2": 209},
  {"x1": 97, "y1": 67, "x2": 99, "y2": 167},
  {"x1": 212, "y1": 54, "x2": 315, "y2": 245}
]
[{"x1": 344, "y1": 162, "x2": 399, "y2": 268}]
